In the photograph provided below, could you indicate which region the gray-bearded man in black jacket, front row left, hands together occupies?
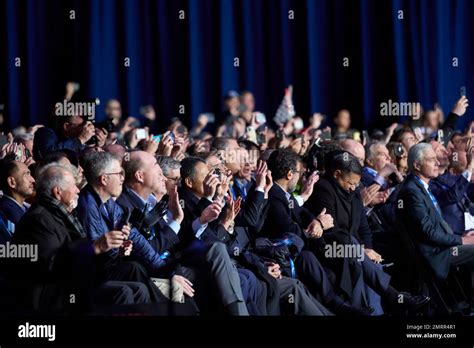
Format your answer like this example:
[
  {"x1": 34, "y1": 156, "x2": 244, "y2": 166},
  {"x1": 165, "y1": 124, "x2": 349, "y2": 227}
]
[{"x1": 11, "y1": 162, "x2": 150, "y2": 311}]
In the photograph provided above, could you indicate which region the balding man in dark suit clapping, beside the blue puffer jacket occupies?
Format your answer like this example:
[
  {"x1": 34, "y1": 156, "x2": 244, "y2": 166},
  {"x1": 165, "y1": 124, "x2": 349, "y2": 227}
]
[{"x1": 117, "y1": 151, "x2": 252, "y2": 314}]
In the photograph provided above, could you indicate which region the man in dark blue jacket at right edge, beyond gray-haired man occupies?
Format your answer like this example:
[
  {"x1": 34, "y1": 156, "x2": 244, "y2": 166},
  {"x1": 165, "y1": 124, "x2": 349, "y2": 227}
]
[{"x1": 429, "y1": 140, "x2": 474, "y2": 235}]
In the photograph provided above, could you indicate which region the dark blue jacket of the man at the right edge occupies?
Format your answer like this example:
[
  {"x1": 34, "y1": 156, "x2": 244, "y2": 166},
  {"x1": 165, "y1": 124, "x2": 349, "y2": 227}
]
[{"x1": 430, "y1": 173, "x2": 474, "y2": 235}]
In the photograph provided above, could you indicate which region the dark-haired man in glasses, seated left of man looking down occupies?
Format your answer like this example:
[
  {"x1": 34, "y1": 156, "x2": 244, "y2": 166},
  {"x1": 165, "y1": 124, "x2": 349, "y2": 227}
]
[{"x1": 262, "y1": 149, "x2": 380, "y2": 315}]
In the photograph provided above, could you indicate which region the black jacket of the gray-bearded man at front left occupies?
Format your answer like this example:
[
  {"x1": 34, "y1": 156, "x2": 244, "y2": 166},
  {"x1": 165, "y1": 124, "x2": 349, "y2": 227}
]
[{"x1": 11, "y1": 203, "x2": 98, "y2": 309}]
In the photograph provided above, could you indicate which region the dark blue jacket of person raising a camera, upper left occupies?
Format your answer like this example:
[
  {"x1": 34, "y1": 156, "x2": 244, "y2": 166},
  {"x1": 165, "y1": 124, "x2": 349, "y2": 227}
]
[{"x1": 33, "y1": 127, "x2": 84, "y2": 161}]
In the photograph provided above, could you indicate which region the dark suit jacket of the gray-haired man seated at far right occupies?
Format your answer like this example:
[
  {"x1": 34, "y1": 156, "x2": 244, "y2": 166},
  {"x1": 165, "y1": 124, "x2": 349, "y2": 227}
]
[{"x1": 397, "y1": 175, "x2": 462, "y2": 279}]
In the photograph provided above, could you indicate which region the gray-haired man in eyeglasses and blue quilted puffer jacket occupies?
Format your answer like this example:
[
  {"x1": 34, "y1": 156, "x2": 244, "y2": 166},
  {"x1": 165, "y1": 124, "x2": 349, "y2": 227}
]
[{"x1": 77, "y1": 152, "x2": 185, "y2": 308}]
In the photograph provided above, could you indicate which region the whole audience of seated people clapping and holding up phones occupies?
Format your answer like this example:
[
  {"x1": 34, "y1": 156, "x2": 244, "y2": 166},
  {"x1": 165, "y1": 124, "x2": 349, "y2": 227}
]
[{"x1": 0, "y1": 85, "x2": 474, "y2": 317}]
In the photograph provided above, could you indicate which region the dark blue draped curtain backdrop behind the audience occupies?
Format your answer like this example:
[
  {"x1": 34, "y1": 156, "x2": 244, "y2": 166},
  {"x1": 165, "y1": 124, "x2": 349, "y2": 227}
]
[{"x1": 0, "y1": 0, "x2": 474, "y2": 131}]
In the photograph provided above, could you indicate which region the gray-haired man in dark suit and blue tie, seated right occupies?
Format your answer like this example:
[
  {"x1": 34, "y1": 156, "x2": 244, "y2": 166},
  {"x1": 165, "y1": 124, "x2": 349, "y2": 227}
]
[{"x1": 397, "y1": 143, "x2": 474, "y2": 279}]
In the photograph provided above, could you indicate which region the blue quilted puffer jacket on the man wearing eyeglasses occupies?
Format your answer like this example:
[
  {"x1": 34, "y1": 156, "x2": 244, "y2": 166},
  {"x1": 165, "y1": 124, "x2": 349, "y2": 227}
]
[{"x1": 77, "y1": 185, "x2": 164, "y2": 272}]
